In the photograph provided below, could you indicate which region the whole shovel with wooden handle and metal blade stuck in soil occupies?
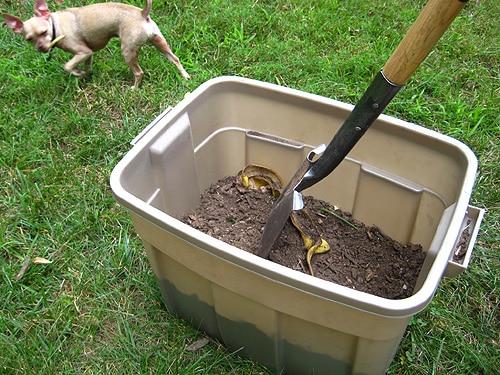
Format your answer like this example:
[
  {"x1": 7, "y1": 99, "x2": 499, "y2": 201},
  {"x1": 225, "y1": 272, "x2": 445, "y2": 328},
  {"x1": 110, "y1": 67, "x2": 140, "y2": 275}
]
[{"x1": 256, "y1": 0, "x2": 467, "y2": 258}]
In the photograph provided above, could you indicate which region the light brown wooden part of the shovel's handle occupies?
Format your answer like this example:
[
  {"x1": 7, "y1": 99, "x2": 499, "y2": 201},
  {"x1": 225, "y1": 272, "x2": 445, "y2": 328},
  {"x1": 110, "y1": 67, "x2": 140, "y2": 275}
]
[{"x1": 382, "y1": 0, "x2": 467, "y2": 86}]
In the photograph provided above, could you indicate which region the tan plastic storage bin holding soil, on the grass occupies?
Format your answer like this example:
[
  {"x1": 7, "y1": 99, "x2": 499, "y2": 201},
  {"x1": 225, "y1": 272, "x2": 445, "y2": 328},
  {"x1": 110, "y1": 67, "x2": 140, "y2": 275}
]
[{"x1": 111, "y1": 77, "x2": 483, "y2": 375}]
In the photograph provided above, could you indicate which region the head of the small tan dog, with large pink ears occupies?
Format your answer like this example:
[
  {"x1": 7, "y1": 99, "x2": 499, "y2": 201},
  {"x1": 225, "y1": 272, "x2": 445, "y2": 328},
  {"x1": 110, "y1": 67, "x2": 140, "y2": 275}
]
[{"x1": 3, "y1": 0, "x2": 53, "y2": 52}]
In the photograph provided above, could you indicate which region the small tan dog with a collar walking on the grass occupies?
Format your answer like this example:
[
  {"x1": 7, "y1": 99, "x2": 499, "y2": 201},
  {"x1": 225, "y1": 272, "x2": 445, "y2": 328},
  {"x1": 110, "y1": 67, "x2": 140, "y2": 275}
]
[{"x1": 3, "y1": 0, "x2": 190, "y2": 89}]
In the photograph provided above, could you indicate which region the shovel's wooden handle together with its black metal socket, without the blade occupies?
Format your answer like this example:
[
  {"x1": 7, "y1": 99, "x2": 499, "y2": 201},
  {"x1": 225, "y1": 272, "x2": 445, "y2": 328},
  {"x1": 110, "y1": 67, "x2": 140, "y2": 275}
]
[{"x1": 296, "y1": 0, "x2": 466, "y2": 191}]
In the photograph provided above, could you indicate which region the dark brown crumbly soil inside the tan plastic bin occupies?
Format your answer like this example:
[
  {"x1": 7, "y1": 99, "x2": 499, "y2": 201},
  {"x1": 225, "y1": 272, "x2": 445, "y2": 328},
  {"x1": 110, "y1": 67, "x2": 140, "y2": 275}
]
[{"x1": 182, "y1": 176, "x2": 425, "y2": 299}]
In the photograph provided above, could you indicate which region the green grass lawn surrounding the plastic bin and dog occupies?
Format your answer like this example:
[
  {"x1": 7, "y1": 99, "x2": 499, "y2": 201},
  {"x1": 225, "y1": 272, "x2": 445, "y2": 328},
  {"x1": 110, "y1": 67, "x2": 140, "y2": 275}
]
[{"x1": 0, "y1": 0, "x2": 500, "y2": 374}]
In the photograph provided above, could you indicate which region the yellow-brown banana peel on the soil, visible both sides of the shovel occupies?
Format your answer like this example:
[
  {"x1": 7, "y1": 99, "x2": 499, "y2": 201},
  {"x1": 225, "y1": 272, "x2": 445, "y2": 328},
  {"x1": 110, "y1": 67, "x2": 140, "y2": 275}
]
[{"x1": 240, "y1": 164, "x2": 330, "y2": 276}]
